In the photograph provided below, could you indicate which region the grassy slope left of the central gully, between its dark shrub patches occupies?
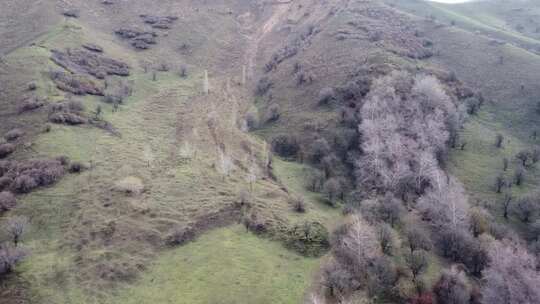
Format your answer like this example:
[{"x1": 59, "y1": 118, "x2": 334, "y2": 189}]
[{"x1": 0, "y1": 1, "x2": 339, "y2": 303}]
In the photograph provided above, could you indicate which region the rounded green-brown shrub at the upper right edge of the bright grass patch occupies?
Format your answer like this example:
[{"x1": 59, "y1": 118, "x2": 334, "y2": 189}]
[{"x1": 287, "y1": 221, "x2": 330, "y2": 256}]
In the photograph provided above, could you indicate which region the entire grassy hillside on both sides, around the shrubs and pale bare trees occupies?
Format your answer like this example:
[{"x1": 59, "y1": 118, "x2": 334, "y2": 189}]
[{"x1": 0, "y1": 0, "x2": 540, "y2": 304}]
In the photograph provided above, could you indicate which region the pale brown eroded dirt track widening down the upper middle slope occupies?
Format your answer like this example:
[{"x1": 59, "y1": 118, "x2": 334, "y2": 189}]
[{"x1": 170, "y1": 1, "x2": 293, "y2": 171}]
